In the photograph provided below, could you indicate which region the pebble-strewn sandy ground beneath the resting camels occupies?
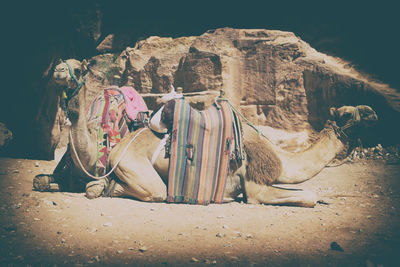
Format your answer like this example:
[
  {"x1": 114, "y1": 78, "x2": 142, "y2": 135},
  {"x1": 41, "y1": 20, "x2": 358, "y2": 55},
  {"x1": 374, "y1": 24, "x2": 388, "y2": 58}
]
[{"x1": 0, "y1": 158, "x2": 400, "y2": 267}]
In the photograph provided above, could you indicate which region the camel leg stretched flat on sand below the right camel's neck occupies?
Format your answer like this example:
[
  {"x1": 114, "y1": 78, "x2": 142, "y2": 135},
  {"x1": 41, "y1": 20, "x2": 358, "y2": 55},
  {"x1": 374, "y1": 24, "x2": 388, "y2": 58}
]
[{"x1": 245, "y1": 181, "x2": 318, "y2": 208}]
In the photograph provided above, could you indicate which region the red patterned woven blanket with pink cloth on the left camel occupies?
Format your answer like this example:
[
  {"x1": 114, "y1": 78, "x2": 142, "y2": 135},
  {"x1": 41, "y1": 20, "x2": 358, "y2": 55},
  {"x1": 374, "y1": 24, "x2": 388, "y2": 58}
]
[{"x1": 87, "y1": 87, "x2": 148, "y2": 176}]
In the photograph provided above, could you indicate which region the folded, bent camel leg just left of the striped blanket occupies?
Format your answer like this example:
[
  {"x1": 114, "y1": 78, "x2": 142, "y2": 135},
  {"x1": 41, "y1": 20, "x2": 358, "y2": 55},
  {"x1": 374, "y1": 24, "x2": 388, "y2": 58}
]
[{"x1": 113, "y1": 159, "x2": 167, "y2": 202}]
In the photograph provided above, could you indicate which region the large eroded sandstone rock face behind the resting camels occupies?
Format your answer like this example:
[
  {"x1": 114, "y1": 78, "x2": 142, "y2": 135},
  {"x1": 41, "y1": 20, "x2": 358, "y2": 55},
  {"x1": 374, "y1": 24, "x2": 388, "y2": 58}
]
[{"x1": 39, "y1": 28, "x2": 400, "y2": 160}]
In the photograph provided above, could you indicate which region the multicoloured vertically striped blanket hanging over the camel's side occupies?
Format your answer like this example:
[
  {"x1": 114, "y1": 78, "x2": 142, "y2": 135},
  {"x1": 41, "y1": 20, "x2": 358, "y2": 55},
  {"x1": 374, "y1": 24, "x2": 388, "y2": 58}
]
[{"x1": 167, "y1": 99, "x2": 241, "y2": 205}]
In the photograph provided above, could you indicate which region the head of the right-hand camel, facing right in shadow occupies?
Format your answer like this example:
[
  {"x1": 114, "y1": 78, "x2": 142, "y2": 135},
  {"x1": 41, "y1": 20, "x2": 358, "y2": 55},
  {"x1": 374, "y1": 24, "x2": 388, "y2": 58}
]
[{"x1": 330, "y1": 105, "x2": 378, "y2": 132}]
